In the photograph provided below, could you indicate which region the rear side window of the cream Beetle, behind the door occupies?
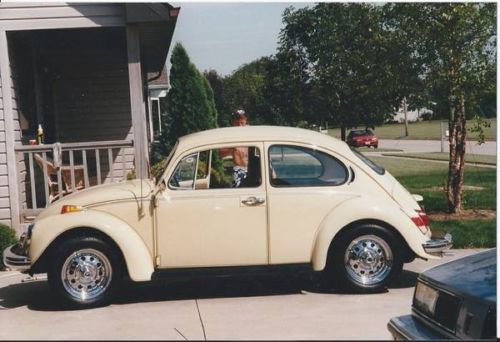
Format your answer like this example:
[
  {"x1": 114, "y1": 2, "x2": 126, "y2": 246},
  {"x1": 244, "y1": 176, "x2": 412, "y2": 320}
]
[{"x1": 269, "y1": 145, "x2": 348, "y2": 187}]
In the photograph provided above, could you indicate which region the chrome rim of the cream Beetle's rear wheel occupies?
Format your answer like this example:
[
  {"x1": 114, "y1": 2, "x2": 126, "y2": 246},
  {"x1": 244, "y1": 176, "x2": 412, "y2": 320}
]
[{"x1": 344, "y1": 235, "x2": 393, "y2": 286}]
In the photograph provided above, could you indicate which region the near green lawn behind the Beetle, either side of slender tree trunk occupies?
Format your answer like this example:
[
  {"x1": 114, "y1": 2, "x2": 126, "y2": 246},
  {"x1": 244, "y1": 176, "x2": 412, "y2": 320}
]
[{"x1": 370, "y1": 157, "x2": 496, "y2": 212}]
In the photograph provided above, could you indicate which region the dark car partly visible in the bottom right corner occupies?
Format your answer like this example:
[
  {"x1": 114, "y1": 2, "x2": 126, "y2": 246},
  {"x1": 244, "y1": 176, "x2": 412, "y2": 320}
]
[{"x1": 388, "y1": 249, "x2": 497, "y2": 340}]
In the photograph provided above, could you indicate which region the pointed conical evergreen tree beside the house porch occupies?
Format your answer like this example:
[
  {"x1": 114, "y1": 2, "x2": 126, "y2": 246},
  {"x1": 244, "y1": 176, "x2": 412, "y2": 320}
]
[{"x1": 151, "y1": 43, "x2": 217, "y2": 164}]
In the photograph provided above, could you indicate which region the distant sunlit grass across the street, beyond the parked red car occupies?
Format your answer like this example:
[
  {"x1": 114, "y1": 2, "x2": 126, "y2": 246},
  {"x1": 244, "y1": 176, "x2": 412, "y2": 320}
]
[{"x1": 328, "y1": 119, "x2": 497, "y2": 140}]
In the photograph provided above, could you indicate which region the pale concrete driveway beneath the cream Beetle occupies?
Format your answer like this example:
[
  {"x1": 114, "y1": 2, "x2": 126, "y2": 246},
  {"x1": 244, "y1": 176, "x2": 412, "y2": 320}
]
[{"x1": 0, "y1": 250, "x2": 480, "y2": 340}]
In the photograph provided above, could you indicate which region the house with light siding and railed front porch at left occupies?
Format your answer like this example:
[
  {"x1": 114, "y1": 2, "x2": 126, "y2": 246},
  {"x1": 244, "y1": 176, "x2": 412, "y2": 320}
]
[{"x1": 0, "y1": 2, "x2": 179, "y2": 232}]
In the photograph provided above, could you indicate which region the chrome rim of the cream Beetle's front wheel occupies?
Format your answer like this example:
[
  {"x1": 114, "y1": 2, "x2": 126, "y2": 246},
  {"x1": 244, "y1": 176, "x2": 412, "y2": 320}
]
[{"x1": 61, "y1": 248, "x2": 113, "y2": 302}]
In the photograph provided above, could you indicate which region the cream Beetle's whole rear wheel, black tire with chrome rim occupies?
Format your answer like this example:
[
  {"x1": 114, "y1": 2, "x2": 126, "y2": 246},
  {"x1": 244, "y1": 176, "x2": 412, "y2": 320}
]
[{"x1": 324, "y1": 224, "x2": 403, "y2": 293}]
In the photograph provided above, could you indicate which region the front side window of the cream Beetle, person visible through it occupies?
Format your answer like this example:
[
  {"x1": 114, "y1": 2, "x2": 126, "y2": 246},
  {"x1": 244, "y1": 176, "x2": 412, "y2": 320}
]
[{"x1": 169, "y1": 146, "x2": 262, "y2": 190}]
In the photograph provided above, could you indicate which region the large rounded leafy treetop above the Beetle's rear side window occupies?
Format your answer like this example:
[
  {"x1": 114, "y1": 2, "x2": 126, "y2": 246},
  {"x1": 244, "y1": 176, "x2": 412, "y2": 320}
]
[{"x1": 278, "y1": 3, "x2": 411, "y2": 138}]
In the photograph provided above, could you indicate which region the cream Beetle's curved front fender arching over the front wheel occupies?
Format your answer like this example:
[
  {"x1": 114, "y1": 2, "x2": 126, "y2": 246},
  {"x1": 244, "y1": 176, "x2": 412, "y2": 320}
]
[{"x1": 30, "y1": 210, "x2": 154, "y2": 281}]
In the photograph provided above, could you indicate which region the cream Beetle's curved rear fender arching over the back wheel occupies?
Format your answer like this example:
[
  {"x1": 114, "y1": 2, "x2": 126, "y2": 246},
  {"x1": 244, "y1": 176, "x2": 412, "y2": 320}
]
[{"x1": 311, "y1": 196, "x2": 437, "y2": 271}]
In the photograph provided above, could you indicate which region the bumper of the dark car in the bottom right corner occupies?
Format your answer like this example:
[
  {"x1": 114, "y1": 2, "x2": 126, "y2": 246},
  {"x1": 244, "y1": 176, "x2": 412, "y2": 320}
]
[{"x1": 387, "y1": 315, "x2": 449, "y2": 341}]
